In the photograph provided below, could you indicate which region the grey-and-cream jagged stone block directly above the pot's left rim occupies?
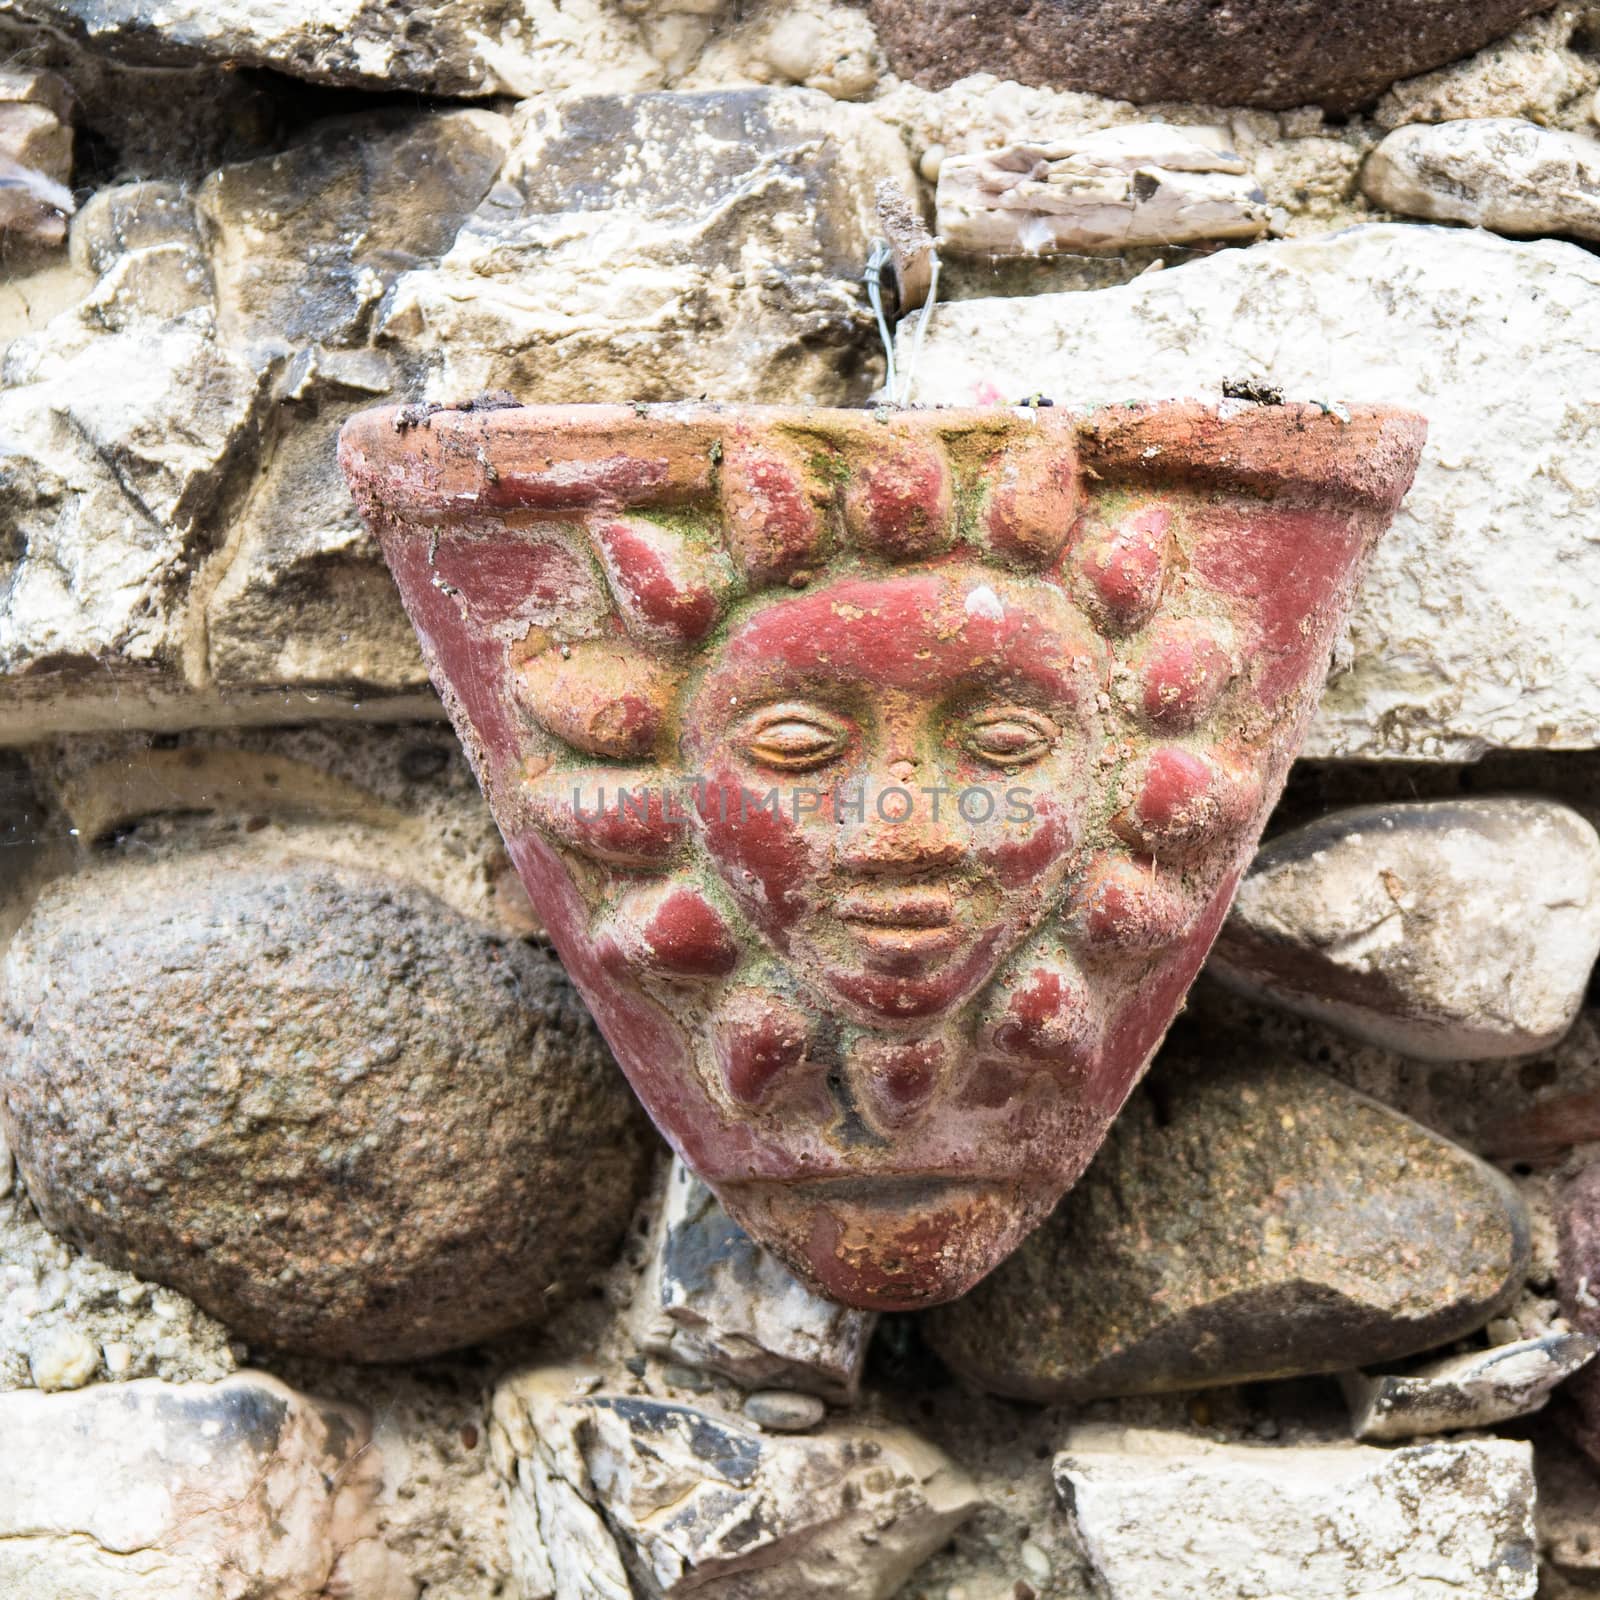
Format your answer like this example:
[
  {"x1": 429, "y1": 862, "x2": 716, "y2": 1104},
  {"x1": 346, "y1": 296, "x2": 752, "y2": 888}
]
[{"x1": 382, "y1": 90, "x2": 912, "y2": 403}]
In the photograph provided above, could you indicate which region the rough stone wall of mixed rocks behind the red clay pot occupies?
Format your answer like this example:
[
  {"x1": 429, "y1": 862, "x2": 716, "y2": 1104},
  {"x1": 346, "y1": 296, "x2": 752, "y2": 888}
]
[{"x1": 0, "y1": 0, "x2": 1600, "y2": 1600}]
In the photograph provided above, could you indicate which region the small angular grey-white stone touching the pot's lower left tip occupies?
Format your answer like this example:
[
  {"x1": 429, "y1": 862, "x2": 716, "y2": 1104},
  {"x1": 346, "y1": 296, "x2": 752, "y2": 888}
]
[{"x1": 634, "y1": 1157, "x2": 877, "y2": 1402}]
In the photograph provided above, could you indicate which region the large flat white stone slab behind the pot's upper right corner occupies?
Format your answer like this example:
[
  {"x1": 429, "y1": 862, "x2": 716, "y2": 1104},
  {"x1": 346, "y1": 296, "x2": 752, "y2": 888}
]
[{"x1": 914, "y1": 224, "x2": 1600, "y2": 762}]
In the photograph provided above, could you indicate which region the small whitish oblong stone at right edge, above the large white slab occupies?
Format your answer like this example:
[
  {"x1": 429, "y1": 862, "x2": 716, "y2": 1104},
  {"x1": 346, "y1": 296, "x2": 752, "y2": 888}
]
[{"x1": 1362, "y1": 117, "x2": 1600, "y2": 238}]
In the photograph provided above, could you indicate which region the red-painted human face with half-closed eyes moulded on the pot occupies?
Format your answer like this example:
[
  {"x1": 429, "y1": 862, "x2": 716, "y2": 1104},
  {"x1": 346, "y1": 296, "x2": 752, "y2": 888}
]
[{"x1": 685, "y1": 566, "x2": 1099, "y2": 1022}]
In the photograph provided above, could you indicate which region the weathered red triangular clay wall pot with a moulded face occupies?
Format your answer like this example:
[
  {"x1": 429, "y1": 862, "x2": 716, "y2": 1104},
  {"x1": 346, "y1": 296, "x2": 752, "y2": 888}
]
[{"x1": 341, "y1": 403, "x2": 1424, "y2": 1309}]
